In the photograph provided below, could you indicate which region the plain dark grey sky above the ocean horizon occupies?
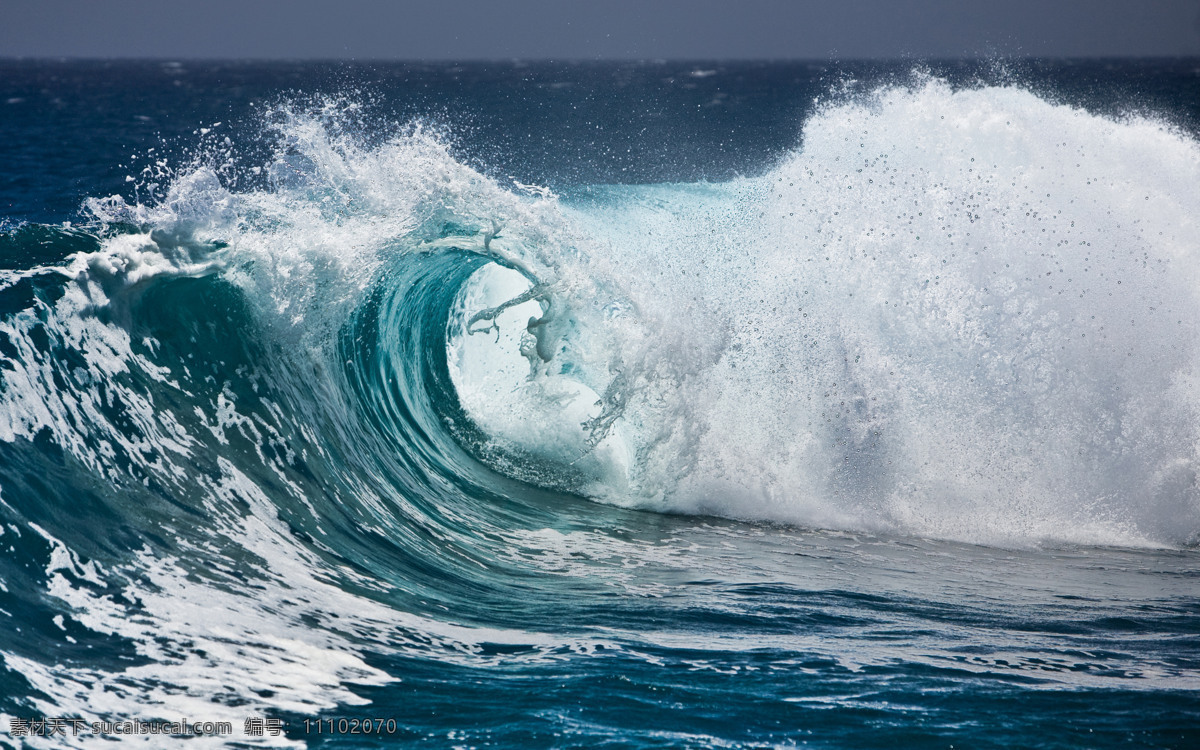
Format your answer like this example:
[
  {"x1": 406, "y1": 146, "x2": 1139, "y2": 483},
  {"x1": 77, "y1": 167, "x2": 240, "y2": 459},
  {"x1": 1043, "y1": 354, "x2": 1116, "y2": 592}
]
[{"x1": 0, "y1": 0, "x2": 1200, "y2": 60}]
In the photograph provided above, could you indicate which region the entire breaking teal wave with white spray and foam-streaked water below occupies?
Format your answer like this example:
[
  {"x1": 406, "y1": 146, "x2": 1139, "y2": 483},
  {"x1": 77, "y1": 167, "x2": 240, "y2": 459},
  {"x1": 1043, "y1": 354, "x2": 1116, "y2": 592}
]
[{"x1": 0, "y1": 65, "x2": 1200, "y2": 746}]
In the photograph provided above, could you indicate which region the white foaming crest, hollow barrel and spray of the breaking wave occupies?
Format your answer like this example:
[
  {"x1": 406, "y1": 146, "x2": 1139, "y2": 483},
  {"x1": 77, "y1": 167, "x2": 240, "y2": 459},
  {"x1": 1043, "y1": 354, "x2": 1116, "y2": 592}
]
[{"x1": 8, "y1": 80, "x2": 1200, "y2": 545}]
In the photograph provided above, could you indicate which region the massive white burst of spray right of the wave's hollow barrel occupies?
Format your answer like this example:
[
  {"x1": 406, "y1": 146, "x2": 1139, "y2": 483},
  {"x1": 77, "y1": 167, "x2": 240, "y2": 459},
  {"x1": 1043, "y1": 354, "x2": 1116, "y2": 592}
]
[{"x1": 556, "y1": 80, "x2": 1200, "y2": 545}]
